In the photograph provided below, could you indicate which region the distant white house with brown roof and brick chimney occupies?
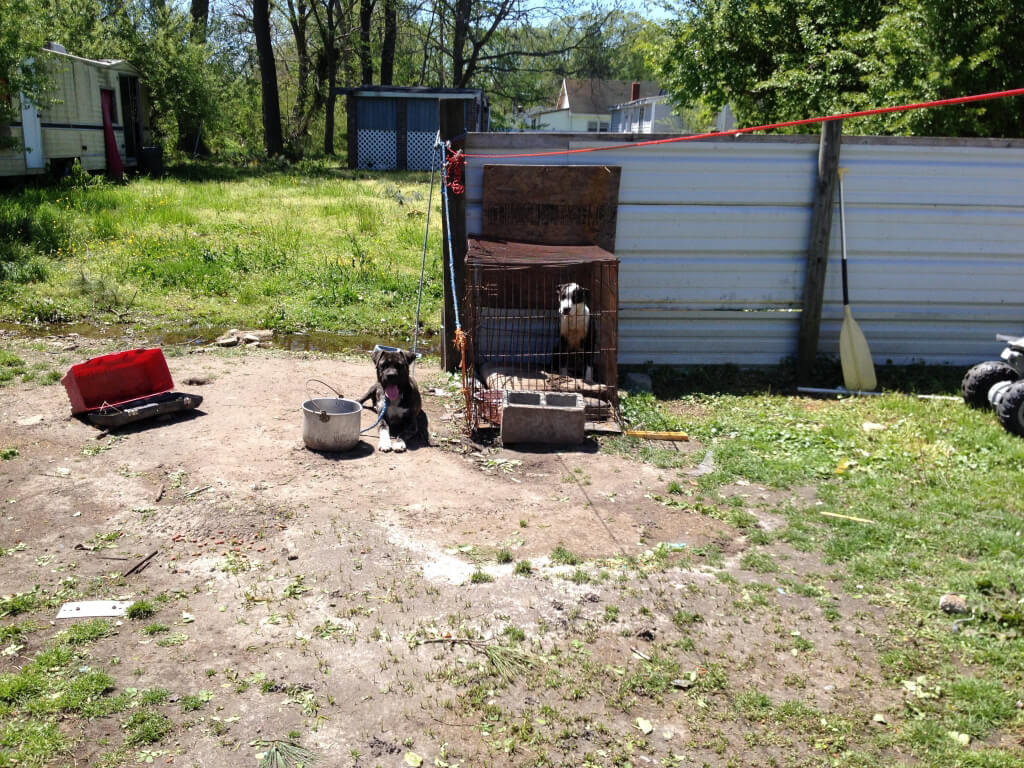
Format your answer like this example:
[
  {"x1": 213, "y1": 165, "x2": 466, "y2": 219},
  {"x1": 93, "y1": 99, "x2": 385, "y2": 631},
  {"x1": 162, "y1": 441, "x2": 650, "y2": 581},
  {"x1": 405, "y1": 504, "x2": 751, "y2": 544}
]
[{"x1": 526, "y1": 78, "x2": 660, "y2": 133}]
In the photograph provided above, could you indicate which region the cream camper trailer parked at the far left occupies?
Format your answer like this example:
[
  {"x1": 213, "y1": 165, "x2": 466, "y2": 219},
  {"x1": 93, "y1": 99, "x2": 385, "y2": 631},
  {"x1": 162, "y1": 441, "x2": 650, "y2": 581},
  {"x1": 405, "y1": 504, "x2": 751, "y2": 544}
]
[{"x1": 0, "y1": 43, "x2": 151, "y2": 176}]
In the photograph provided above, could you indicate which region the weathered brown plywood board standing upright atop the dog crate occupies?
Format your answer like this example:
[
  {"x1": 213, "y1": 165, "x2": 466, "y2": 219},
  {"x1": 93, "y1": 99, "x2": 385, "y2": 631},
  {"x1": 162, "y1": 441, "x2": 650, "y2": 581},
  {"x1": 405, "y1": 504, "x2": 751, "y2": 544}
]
[{"x1": 481, "y1": 165, "x2": 622, "y2": 251}]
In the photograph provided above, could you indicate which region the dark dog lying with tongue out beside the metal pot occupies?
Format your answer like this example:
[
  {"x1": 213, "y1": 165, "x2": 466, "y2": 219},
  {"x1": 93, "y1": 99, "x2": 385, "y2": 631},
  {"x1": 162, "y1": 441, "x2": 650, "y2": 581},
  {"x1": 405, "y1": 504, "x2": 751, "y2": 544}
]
[{"x1": 359, "y1": 348, "x2": 430, "y2": 453}]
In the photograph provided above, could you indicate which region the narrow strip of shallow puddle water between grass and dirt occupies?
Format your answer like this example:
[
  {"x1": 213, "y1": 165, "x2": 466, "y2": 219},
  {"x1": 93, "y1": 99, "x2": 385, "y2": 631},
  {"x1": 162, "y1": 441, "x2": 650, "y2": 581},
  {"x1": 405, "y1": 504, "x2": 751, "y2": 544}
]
[{"x1": 0, "y1": 323, "x2": 441, "y2": 355}]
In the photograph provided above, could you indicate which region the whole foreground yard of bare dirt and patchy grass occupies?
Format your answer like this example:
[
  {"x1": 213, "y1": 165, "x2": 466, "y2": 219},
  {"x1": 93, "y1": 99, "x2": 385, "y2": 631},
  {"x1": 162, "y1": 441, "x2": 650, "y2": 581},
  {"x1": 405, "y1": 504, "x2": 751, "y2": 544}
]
[{"x1": 0, "y1": 335, "x2": 1024, "y2": 767}]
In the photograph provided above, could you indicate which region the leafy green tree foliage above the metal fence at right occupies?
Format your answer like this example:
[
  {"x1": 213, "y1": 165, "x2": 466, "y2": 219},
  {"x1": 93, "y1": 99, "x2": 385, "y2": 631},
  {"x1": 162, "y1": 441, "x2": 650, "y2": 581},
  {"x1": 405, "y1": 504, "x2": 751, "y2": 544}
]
[{"x1": 656, "y1": 0, "x2": 1024, "y2": 136}]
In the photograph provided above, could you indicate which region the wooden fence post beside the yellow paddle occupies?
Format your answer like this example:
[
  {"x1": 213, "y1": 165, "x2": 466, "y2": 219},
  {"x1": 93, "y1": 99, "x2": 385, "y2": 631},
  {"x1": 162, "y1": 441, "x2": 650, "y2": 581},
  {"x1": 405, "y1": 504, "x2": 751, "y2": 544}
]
[{"x1": 797, "y1": 120, "x2": 843, "y2": 384}]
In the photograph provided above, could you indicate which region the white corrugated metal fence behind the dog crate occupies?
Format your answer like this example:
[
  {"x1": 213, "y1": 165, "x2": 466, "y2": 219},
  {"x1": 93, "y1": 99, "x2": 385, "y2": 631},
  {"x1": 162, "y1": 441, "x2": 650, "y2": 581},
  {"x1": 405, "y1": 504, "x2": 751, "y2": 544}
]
[{"x1": 466, "y1": 133, "x2": 1024, "y2": 365}]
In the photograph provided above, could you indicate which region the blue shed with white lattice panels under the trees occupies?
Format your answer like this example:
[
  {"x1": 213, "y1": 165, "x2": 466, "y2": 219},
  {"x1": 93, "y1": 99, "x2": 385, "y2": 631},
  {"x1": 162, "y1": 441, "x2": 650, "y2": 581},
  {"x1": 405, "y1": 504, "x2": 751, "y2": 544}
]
[{"x1": 338, "y1": 85, "x2": 490, "y2": 171}]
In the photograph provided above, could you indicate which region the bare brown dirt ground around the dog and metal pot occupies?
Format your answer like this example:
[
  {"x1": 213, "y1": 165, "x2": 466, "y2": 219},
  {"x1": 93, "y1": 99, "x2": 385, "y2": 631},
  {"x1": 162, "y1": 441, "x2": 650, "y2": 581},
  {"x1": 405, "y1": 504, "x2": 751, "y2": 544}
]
[{"x1": 0, "y1": 340, "x2": 887, "y2": 767}]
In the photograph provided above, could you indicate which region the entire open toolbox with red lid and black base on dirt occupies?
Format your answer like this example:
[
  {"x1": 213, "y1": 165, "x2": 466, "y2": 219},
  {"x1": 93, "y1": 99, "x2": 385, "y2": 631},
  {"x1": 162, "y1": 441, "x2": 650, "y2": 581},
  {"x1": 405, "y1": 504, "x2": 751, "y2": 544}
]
[{"x1": 60, "y1": 347, "x2": 203, "y2": 427}]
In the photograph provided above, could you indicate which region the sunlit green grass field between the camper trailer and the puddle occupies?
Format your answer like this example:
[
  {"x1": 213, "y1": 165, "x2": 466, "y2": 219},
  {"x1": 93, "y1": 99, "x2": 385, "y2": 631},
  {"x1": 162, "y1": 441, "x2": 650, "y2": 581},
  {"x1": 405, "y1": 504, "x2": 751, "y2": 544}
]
[{"x1": 0, "y1": 169, "x2": 442, "y2": 335}]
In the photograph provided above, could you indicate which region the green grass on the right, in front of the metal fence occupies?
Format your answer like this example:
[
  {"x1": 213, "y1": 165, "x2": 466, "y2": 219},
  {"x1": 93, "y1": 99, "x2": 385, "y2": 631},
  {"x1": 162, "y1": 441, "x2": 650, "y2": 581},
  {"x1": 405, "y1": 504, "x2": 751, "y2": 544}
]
[{"x1": 605, "y1": 367, "x2": 1024, "y2": 766}]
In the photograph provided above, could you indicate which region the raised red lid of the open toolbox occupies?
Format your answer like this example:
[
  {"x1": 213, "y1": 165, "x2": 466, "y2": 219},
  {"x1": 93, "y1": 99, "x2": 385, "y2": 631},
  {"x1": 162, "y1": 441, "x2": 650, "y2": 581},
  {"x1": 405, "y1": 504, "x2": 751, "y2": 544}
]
[{"x1": 60, "y1": 347, "x2": 174, "y2": 414}]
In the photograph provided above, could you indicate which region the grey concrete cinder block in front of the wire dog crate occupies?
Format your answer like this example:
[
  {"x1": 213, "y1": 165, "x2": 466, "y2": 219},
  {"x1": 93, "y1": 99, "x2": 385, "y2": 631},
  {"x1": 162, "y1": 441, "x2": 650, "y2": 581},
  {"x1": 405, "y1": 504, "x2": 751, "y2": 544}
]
[{"x1": 502, "y1": 392, "x2": 587, "y2": 445}]
